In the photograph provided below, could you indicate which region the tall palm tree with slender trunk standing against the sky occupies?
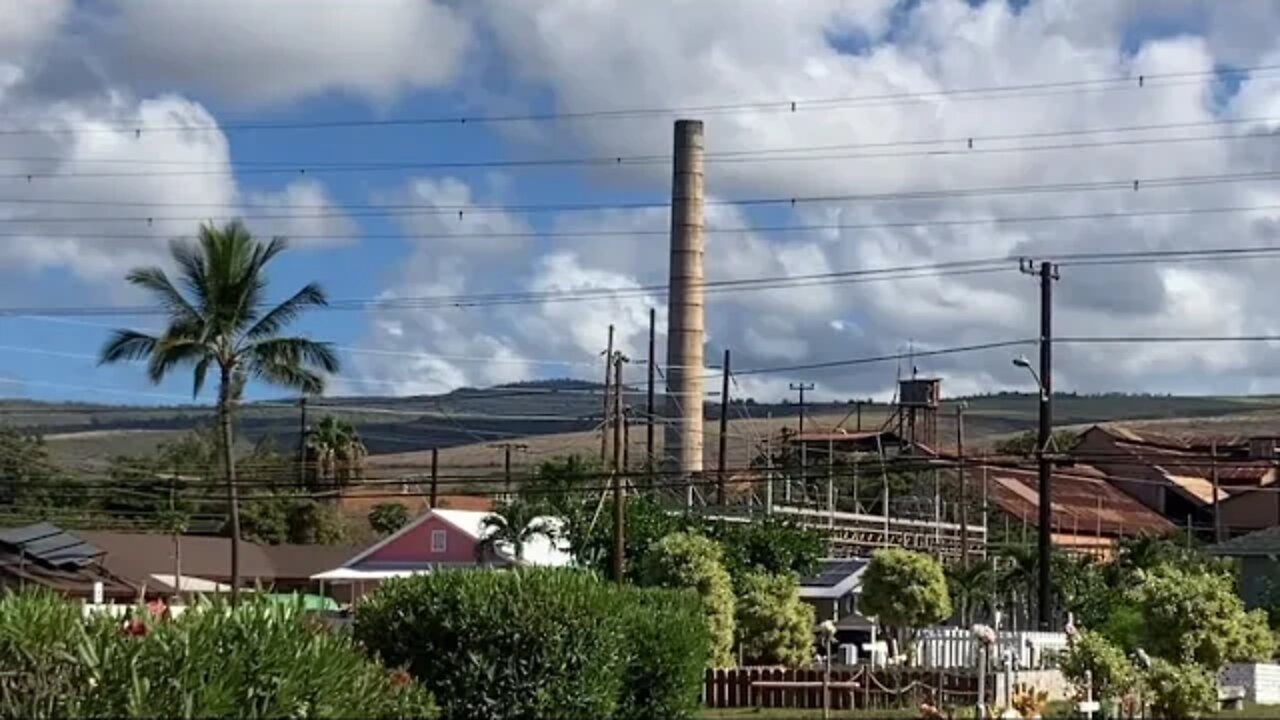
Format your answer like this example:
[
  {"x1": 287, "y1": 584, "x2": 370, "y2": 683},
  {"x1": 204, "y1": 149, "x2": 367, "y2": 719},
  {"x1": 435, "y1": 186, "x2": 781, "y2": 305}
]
[{"x1": 100, "y1": 222, "x2": 338, "y2": 602}]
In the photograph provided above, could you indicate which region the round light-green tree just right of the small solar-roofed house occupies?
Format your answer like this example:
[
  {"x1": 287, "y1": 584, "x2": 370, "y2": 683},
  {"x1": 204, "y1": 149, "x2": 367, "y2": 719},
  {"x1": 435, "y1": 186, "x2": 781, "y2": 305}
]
[{"x1": 861, "y1": 548, "x2": 951, "y2": 652}]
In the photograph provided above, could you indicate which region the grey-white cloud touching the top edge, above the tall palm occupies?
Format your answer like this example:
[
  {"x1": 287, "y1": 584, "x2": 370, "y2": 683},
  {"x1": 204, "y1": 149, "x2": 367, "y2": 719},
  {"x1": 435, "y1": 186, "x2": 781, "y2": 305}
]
[{"x1": 97, "y1": 0, "x2": 471, "y2": 105}]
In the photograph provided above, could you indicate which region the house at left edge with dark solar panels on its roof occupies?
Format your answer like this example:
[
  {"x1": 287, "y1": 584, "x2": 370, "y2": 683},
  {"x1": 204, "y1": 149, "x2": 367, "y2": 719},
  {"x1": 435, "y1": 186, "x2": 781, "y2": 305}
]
[{"x1": 0, "y1": 523, "x2": 138, "y2": 601}]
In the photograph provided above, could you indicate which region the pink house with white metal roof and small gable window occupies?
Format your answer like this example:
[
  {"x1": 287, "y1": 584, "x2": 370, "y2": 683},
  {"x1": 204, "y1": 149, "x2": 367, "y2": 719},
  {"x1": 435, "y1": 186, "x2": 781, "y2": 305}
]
[{"x1": 311, "y1": 509, "x2": 572, "y2": 600}]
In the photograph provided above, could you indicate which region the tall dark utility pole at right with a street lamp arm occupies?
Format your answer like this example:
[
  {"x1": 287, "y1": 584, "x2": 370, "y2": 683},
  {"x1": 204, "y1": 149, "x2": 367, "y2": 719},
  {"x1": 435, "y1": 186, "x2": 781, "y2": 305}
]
[{"x1": 1021, "y1": 260, "x2": 1059, "y2": 632}]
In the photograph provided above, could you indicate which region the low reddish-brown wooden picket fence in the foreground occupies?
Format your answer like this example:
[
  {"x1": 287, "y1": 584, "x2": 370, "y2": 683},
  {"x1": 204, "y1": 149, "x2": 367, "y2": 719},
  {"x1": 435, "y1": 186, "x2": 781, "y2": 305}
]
[{"x1": 703, "y1": 665, "x2": 996, "y2": 710}]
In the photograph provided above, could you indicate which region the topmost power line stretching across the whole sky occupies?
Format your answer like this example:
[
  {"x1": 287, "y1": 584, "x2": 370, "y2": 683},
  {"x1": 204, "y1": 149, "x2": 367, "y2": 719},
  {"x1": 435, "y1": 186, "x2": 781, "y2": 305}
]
[{"x1": 0, "y1": 65, "x2": 1280, "y2": 137}]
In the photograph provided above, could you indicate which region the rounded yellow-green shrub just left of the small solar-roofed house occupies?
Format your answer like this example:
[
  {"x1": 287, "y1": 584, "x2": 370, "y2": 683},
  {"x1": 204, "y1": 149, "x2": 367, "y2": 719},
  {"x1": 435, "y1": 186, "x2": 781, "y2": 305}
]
[{"x1": 735, "y1": 571, "x2": 814, "y2": 667}]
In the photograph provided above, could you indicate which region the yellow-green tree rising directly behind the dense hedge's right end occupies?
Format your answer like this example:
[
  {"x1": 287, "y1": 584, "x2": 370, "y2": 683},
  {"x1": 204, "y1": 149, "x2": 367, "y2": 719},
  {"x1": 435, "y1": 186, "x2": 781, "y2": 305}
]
[{"x1": 643, "y1": 533, "x2": 735, "y2": 667}]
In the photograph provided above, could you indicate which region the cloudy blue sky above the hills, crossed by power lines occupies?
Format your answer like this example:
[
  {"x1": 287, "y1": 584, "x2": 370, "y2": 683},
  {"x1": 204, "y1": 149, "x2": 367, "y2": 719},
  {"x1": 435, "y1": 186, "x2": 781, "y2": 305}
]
[{"x1": 0, "y1": 0, "x2": 1280, "y2": 401}]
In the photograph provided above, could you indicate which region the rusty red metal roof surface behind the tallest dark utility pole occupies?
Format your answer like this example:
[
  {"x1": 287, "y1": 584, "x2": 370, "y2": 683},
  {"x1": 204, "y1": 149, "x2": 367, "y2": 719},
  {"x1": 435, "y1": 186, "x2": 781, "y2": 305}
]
[{"x1": 969, "y1": 465, "x2": 1174, "y2": 537}]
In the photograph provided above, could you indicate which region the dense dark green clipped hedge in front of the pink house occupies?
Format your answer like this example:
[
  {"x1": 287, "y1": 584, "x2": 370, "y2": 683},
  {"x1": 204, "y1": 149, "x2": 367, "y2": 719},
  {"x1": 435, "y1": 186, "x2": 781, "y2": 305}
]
[{"x1": 355, "y1": 569, "x2": 709, "y2": 720}]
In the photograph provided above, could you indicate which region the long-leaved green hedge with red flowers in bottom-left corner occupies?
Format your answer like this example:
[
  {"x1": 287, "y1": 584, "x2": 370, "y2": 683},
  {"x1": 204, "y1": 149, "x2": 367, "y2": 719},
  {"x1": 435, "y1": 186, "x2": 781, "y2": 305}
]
[{"x1": 0, "y1": 593, "x2": 436, "y2": 717}]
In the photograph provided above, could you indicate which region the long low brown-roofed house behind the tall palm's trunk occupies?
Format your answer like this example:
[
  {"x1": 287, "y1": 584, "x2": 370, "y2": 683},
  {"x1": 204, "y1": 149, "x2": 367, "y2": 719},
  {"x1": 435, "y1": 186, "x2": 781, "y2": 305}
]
[{"x1": 78, "y1": 530, "x2": 357, "y2": 594}]
